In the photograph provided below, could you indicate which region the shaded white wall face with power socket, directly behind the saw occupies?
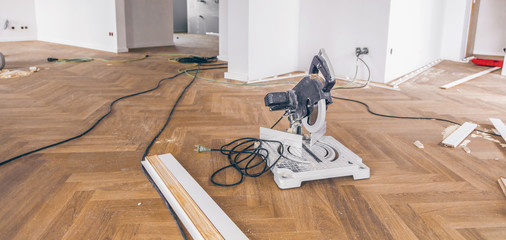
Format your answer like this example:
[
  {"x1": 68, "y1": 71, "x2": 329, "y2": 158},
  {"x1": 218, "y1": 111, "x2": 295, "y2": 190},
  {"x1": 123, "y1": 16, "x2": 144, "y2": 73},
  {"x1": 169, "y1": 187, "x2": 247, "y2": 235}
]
[{"x1": 298, "y1": 0, "x2": 390, "y2": 82}]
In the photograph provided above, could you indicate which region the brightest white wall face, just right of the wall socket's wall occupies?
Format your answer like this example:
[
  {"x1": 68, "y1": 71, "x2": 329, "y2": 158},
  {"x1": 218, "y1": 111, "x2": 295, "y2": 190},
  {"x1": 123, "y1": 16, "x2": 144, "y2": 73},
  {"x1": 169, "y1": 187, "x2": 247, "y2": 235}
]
[{"x1": 384, "y1": 0, "x2": 445, "y2": 82}]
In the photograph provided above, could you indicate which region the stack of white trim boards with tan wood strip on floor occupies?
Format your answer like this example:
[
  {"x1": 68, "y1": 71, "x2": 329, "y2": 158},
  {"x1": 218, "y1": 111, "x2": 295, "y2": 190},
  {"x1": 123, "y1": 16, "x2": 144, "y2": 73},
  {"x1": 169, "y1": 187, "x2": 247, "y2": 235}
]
[{"x1": 142, "y1": 154, "x2": 248, "y2": 239}]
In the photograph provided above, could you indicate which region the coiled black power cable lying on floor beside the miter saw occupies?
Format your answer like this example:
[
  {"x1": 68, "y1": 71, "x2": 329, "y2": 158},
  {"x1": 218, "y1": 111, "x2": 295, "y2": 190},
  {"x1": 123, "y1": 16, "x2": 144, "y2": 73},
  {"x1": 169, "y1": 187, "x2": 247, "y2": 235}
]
[{"x1": 208, "y1": 113, "x2": 286, "y2": 187}]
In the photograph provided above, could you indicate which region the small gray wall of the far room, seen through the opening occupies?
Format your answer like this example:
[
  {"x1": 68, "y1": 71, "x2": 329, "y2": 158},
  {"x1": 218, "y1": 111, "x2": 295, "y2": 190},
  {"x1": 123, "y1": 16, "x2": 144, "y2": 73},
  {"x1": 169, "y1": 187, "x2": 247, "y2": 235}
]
[{"x1": 187, "y1": 0, "x2": 219, "y2": 34}]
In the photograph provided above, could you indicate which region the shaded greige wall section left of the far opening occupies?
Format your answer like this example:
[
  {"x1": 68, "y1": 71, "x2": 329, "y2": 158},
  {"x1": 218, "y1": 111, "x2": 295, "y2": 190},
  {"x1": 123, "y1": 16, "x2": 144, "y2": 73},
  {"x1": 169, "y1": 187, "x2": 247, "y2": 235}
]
[{"x1": 125, "y1": 0, "x2": 174, "y2": 48}]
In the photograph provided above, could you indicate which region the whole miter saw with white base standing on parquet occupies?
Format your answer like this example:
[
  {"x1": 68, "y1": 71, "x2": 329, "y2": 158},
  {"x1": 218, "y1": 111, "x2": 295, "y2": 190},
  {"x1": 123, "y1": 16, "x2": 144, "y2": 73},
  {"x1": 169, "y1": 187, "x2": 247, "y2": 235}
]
[{"x1": 260, "y1": 49, "x2": 369, "y2": 189}]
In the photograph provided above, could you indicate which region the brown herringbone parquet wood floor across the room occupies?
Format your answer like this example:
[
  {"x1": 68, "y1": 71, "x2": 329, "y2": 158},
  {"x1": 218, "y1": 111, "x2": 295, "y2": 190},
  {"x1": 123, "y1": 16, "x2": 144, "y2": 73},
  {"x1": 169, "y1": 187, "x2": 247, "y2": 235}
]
[{"x1": 0, "y1": 35, "x2": 506, "y2": 239}]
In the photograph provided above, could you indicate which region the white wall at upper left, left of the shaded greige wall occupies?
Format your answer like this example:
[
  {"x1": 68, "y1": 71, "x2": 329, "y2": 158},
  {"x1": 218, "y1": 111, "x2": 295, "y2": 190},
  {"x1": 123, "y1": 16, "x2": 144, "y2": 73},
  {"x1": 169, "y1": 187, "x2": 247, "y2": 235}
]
[{"x1": 35, "y1": 0, "x2": 119, "y2": 52}]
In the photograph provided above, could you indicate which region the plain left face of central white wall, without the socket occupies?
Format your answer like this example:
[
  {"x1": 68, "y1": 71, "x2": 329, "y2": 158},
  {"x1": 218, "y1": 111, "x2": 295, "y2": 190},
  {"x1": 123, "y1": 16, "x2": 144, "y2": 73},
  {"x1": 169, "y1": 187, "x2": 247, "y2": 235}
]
[{"x1": 248, "y1": 0, "x2": 300, "y2": 79}]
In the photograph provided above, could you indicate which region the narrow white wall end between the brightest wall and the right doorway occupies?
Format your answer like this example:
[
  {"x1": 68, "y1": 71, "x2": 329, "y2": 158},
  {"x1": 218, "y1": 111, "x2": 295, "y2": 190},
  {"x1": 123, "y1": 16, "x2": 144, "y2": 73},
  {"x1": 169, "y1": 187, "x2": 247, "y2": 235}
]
[{"x1": 441, "y1": 0, "x2": 473, "y2": 60}]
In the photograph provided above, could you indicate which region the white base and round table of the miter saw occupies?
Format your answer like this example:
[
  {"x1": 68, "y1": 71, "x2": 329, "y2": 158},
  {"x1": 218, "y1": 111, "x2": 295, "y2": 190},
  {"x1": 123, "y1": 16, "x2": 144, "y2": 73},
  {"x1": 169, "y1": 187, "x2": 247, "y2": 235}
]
[{"x1": 260, "y1": 126, "x2": 370, "y2": 189}]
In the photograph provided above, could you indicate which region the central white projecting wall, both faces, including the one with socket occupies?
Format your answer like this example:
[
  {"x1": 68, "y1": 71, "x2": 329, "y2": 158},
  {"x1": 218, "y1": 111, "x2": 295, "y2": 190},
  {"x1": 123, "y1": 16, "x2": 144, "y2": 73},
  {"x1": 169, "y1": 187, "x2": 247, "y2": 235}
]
[{"x1": 226, "y1": 0, "x2": 390, "y2": 82}]
